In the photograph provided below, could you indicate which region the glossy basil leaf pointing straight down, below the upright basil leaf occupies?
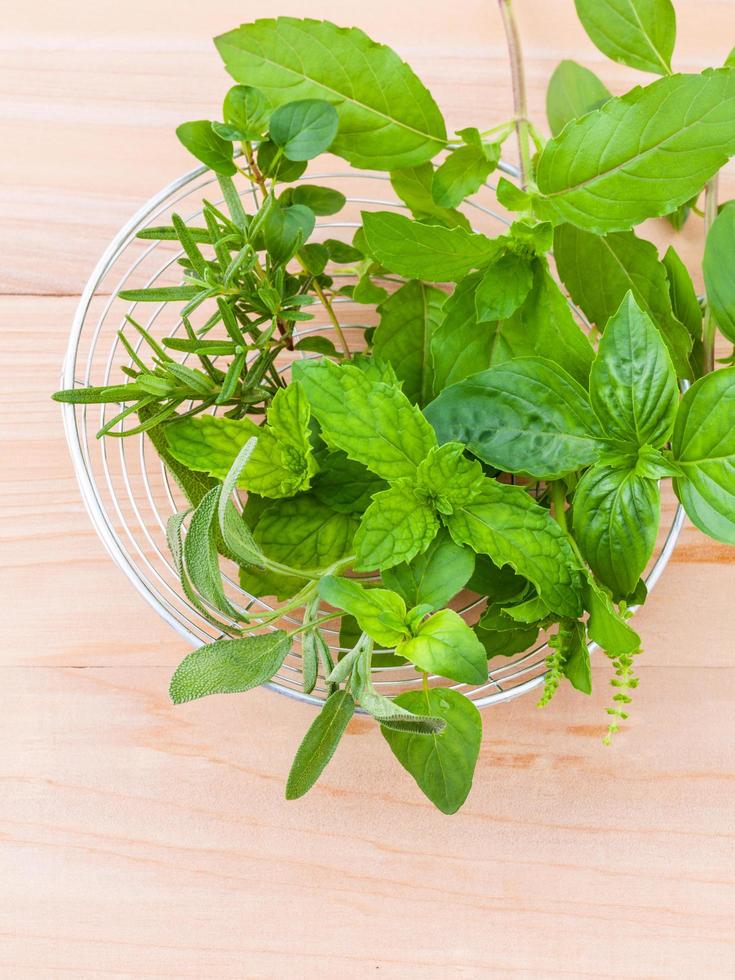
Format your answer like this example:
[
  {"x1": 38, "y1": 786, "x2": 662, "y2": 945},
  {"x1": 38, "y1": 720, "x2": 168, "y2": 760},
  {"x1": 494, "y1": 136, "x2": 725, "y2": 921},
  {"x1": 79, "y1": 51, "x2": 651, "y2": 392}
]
[{"x1": 573, "y1": 464, "x2": 660, "y2": 598}]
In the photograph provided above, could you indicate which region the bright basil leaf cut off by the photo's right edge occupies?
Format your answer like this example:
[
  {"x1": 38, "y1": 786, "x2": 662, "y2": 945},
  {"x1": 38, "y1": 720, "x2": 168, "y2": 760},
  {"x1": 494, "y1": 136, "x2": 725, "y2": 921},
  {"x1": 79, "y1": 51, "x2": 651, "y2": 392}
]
[{"x1": 672, "y1": 367, "x2": 735, "y2": 544}]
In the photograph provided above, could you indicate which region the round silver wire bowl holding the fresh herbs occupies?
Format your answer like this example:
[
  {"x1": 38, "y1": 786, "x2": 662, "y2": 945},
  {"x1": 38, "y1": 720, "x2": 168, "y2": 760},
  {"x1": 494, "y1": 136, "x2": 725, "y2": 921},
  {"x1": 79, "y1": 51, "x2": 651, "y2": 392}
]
[{"x1": 62, "y1": 164, "x2": 684, "y2": 707}]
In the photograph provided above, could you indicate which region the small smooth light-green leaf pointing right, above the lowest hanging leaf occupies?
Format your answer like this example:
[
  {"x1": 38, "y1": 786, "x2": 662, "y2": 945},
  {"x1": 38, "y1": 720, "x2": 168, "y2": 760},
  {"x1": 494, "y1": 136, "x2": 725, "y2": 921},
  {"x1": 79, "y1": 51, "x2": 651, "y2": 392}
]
[{"x1": 396, "y1": 609, "x2": 487, "y2": 684}]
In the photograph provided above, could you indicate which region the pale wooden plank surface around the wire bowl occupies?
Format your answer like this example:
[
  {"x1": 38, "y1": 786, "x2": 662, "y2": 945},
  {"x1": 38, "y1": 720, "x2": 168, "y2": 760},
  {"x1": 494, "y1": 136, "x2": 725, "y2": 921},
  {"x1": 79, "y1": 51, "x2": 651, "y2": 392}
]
[{"x1": 0, "y1": 0, "x2": 735, "y2": 980}]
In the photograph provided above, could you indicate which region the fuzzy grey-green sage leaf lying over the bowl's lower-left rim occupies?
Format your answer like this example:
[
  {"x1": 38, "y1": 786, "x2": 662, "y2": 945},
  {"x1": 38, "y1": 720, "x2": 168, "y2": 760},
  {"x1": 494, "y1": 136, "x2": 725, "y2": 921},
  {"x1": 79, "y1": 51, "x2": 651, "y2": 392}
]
[{"x1": 170, "y1": 630, "x2": 291, "y2": 704}]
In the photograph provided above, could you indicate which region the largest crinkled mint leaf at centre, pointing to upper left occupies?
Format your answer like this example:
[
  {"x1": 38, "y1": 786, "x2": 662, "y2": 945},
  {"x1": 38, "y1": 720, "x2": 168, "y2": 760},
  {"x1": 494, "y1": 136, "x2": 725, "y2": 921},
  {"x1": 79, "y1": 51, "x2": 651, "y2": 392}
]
[{"x1": 294, "y1": 361, "x2": 436, "y2": 480}]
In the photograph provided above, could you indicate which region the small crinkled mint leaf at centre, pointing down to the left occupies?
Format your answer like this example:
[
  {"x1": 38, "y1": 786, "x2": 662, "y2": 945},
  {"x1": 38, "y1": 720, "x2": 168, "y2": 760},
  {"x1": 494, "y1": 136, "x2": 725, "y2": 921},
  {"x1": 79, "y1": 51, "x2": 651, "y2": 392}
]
[{"x1": 354, "y1": 480, "x2": 439, "y2": 572}]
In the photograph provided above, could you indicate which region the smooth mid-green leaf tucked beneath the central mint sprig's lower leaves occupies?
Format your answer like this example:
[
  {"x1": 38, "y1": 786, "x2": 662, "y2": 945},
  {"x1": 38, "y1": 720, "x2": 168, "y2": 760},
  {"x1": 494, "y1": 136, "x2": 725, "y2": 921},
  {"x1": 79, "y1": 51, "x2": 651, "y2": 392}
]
[{"x1": 382, "y1": 529, "x2": 475, "y2": 609}]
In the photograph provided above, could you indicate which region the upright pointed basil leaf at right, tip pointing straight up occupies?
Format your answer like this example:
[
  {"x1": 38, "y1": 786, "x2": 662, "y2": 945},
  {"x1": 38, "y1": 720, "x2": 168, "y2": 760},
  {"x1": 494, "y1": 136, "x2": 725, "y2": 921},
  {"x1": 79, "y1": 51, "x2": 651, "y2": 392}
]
[{"x1": 590, "y1": 293, "x2": 679, "y2": 448}]
